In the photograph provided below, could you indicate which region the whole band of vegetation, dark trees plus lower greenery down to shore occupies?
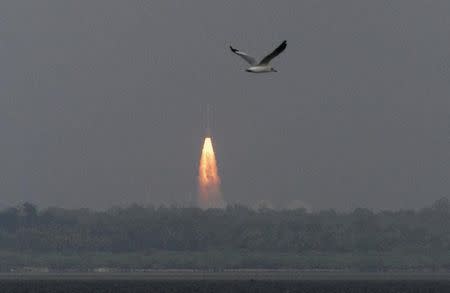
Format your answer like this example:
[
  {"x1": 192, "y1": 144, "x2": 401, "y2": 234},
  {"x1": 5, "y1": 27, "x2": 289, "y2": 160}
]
[{"x1": 0, "y1": 198, "x2": 450, "y2": 269}]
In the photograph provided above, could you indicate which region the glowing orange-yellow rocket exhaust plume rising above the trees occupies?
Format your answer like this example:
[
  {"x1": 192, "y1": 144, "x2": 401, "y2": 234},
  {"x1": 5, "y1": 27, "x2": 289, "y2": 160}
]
[{"x1": 198, "y1": 136, "x2": 225, "y2": 209}]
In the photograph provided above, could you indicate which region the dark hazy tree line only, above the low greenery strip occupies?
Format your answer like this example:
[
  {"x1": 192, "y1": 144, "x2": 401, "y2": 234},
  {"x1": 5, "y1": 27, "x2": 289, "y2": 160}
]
[{"x1": 0, "y1": 198, "x2": 450, "y2": 254}]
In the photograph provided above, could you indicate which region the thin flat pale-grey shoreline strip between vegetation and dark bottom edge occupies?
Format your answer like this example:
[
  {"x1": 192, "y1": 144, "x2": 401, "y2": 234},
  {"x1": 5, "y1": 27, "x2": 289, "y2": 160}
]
[{"x1": 0, "y1": 270, "x2": 450, "y2": 281}]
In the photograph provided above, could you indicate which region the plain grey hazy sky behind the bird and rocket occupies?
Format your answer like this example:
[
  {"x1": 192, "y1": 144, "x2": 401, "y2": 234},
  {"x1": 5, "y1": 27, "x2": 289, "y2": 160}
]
[{"x1": 0, "y1": 0, "x2": 450, "y2": 209}]
